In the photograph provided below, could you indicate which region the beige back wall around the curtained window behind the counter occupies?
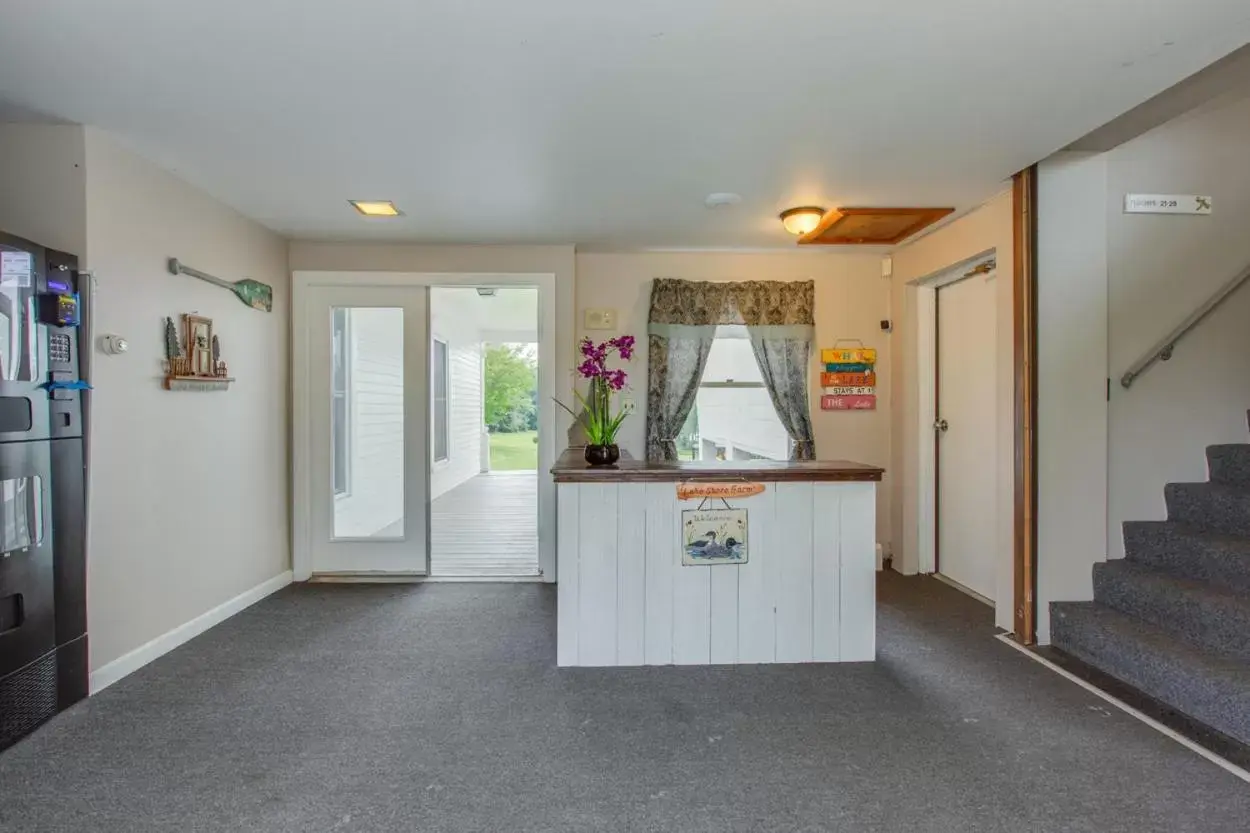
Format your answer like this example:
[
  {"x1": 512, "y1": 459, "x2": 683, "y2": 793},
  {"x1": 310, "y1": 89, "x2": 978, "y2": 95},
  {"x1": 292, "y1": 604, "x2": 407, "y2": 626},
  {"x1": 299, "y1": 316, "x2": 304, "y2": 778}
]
[{"x1": 575, "y1": 251, "x2": 894, "y2": 543}]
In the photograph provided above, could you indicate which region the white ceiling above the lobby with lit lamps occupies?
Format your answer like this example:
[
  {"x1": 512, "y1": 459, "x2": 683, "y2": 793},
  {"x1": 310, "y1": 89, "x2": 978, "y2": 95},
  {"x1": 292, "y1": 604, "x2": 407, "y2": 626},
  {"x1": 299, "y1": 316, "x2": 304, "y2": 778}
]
[{"x1": 0, "y1": 0, "x2": 1250, "y2": 249}]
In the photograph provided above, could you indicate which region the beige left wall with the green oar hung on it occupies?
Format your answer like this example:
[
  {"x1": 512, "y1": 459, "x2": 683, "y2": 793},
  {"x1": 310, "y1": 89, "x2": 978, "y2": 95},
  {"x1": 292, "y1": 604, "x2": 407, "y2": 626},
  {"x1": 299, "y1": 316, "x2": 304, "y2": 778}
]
[{"x1": 79, "y1": 128, "x2": 290, "y2": 669}]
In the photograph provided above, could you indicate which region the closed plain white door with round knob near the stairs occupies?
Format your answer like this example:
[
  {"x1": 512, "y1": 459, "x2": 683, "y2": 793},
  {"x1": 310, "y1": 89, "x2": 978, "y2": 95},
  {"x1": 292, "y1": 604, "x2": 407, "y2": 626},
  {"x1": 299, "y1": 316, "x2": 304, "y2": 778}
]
[{"x1": 935, "y1": 275, "x2": 998, "y2": 599}]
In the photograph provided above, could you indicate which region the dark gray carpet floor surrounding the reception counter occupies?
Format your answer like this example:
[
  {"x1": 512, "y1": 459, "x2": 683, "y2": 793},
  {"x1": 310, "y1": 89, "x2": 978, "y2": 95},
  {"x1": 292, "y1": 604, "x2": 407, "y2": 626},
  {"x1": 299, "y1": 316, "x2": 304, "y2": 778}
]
[{"x1": 0, "y1": 574, "x2": 1250, "y2": 833}]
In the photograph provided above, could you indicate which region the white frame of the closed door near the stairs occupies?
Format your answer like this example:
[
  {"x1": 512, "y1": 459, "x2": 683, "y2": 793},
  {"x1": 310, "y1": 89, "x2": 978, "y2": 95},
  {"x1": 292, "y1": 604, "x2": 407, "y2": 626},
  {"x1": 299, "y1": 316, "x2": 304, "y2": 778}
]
[{"x1": 906, "y1": 249, "x2": 995, "y2": 574}]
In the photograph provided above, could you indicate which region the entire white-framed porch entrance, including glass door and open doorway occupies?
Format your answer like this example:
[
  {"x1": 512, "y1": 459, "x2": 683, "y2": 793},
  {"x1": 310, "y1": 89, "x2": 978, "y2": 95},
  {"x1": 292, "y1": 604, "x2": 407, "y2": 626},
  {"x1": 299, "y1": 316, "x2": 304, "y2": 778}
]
[{"x1": 291, "y1": 271, "x2": 557, "y2": 582}]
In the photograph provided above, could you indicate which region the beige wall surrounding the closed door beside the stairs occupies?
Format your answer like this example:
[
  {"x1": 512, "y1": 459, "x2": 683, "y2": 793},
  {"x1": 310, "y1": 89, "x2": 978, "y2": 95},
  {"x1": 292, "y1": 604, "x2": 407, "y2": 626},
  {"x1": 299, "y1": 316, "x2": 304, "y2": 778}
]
[{"x1": 890, "y1": 190, "x2": 1014, "y2": 629}]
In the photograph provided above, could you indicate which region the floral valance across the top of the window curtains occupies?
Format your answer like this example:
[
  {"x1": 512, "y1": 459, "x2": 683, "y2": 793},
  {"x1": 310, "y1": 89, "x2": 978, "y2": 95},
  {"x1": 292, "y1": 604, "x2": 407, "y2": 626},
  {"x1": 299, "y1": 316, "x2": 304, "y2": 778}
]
[{"x1": 648, "y1": 278, "x2": 816, "y2": 338}]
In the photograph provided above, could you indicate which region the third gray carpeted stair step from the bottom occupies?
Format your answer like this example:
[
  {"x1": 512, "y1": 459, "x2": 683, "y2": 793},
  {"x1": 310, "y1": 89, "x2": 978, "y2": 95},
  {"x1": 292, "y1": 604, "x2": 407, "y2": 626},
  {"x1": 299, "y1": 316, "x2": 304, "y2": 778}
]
[{"x1": 1124, "y1": 520, "x2": 1250, "y2": 590}]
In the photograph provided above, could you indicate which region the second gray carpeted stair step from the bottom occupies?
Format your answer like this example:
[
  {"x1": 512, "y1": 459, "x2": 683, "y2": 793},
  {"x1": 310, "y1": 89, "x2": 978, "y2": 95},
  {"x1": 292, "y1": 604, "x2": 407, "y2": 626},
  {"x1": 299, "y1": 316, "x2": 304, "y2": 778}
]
[{"x1": 1094, "y1": 559, "x2": 1250, "y2": 660}]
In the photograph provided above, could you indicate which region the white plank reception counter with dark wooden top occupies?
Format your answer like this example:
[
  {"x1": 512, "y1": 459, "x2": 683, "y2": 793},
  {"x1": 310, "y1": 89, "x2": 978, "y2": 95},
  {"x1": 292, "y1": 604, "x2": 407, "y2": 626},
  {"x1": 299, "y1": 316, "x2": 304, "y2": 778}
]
[{"x1": 551, "y1": 449, "x2": 883, "y2": 665}]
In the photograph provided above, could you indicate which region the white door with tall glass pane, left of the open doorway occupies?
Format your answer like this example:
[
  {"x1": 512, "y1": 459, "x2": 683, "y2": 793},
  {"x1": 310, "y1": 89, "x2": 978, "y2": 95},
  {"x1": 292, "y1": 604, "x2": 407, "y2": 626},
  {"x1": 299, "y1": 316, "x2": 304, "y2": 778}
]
[{"x1": 296, "y1": 286, "x2": 430, "y2": 575}]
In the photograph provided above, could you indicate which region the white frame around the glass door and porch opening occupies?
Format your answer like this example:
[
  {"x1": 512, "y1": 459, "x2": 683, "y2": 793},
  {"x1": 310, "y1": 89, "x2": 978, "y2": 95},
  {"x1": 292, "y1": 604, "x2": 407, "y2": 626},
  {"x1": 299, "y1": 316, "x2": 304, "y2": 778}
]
[{"x1": 291, "y1": 270, "x2": 564, "y2": 582}]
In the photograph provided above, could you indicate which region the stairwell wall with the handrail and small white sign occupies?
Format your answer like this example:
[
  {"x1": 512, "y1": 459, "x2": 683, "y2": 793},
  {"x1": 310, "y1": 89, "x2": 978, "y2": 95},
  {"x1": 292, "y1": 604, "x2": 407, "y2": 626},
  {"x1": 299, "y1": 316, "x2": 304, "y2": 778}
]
[{"x1": 1100, "y1": 98, "x2": 1250, "y2": 558}]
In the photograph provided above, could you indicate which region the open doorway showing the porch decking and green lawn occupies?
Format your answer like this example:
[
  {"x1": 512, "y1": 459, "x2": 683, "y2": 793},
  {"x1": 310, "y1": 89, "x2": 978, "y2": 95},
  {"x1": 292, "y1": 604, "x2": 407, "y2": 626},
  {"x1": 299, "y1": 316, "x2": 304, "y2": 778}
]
[{"x1": 430, "y1": 286, "x2": 541, "y2": 579}]
